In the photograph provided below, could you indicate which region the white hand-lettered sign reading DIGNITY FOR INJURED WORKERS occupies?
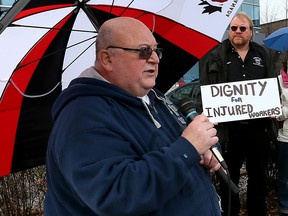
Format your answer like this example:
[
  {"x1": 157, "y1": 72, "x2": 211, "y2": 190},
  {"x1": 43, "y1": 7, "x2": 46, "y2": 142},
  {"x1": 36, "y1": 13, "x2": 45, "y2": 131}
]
[{"x1": 201, "y1": 78, "x2": 281, "y2": 123}]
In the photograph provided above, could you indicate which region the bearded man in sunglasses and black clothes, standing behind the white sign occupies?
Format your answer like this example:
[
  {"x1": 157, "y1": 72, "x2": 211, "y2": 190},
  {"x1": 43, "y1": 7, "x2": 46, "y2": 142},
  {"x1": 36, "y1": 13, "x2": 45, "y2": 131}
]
[{"x1": 200, "y1": 12, "x2": 276, "y2": 216}]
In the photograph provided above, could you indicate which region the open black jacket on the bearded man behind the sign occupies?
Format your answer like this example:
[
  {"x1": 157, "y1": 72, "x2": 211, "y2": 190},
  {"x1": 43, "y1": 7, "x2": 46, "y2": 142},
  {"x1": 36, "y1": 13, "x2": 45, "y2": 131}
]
[{"x1": 200, "y1": 39, "x2": 276, "y2": 146}]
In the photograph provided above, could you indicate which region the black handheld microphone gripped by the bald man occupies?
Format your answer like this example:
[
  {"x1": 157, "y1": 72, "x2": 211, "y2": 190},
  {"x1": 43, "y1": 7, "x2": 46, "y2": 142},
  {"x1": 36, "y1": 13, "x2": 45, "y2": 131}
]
[{"x1": 176, "y1": 97, "x2": 240, "y2": 194}]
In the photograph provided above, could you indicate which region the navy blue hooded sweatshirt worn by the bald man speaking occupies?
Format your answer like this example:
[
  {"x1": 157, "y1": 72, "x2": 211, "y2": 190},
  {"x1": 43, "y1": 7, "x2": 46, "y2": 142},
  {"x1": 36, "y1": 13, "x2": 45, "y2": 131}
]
[{"x1": 45, "y1": 67, "x2": 221, "y2": 216}]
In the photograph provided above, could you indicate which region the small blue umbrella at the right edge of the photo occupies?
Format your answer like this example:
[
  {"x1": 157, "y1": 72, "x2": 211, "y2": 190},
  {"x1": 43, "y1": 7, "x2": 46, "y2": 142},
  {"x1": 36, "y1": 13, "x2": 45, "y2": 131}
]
[{"x1": 263, "y1": 27, "x2": 288, "y2": 53}]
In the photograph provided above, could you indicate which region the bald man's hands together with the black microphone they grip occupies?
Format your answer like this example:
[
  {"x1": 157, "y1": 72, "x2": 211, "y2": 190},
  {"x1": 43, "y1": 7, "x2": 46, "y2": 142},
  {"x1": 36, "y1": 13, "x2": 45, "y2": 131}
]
[{"x1": 177, "y1": 98, "x2": 240, "y2": 194}]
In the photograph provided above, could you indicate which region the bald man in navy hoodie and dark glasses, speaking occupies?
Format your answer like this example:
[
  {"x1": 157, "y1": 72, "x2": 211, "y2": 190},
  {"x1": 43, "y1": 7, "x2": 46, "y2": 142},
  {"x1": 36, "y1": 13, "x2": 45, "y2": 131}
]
[{"x1": 44, "y1": 17, "x2": 221, "y2": 216}]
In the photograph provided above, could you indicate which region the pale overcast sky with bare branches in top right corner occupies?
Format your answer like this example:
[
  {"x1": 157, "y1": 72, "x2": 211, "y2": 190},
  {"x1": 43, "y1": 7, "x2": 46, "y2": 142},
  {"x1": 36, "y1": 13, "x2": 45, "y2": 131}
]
[{"x1": 260, "y1": 0, "x2": 288, "y2": 24}]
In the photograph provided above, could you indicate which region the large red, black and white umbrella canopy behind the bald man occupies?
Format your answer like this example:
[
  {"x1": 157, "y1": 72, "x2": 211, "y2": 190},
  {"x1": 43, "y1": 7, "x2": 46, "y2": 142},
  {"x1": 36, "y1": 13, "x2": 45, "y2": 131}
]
[{"x1": 0, "y1": 0, "x2": 242, "y2": 176}]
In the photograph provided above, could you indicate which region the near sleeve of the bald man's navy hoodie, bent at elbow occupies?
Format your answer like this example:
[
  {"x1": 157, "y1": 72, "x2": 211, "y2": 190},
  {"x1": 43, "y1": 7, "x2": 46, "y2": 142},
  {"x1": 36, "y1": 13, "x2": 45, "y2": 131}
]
[{"x1": 58, "y1": 128, "x2": 200, "y2": 216}]
